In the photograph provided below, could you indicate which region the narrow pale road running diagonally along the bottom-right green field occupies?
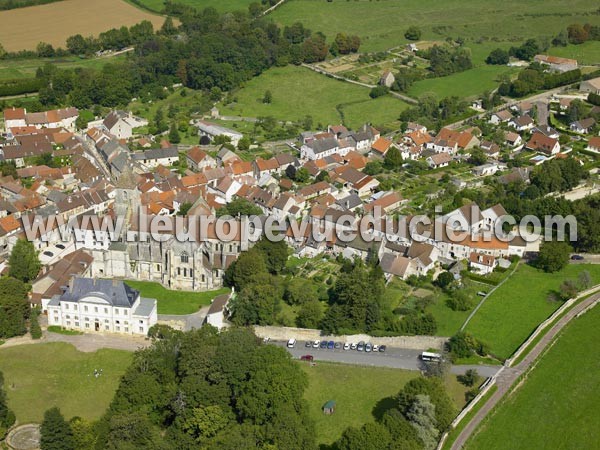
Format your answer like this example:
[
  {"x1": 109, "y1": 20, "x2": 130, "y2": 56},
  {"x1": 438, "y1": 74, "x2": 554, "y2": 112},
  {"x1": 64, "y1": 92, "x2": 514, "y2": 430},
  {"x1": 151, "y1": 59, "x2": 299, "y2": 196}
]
[{"x1": 452, "y1": 294, "x2": 600, "y2": 450}]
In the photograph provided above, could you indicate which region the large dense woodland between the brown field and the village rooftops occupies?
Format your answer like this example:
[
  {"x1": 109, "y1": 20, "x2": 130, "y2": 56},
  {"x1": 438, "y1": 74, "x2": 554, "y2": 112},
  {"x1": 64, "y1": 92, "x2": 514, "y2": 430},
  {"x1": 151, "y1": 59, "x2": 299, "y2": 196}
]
[{"x1": 31, "y1": 8, "x2": 329, "y2": 108}]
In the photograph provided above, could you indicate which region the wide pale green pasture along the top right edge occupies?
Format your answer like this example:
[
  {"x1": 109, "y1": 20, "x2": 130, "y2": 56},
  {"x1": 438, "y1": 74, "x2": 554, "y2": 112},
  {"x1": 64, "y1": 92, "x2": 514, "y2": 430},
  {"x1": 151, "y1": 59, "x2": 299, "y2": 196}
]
[{"x1": 269, "y1": 0, "x2": 600, "y2": 52}]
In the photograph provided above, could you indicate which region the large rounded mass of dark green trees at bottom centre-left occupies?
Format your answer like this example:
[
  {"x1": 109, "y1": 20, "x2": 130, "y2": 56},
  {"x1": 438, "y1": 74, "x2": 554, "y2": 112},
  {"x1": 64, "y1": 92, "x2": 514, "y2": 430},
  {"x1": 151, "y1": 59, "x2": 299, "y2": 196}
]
[{"x1": 41, "y1": 326, "x2": 316, "y2": 450}]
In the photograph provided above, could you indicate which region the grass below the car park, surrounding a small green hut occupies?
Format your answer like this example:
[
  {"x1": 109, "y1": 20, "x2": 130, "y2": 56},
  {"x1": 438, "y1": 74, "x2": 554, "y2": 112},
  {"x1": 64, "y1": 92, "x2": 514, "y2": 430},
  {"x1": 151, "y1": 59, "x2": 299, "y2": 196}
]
[{"x1": 299, "y1": 362, "x2": 465, "y2": 445}]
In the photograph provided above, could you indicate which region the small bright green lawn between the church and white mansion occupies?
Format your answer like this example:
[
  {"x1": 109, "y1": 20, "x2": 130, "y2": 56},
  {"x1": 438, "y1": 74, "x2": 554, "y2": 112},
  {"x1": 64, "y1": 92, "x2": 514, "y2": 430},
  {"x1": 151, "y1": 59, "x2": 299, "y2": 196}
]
[{"x1": 125, "y1": 280, "x2": 229, "y2": 315}]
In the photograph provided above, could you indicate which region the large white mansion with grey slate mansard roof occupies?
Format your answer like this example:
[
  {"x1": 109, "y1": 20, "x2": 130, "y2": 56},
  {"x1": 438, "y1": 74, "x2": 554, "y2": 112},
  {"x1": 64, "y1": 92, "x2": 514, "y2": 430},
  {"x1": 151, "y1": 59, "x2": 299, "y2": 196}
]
[{"x1": 44, "y1": 277, "x2": 158, "y2": 336}]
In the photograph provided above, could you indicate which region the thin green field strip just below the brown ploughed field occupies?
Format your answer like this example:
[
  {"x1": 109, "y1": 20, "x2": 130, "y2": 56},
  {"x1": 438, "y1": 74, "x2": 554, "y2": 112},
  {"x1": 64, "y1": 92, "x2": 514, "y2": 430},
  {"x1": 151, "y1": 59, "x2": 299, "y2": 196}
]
[{"x1": 0, "y1": 54, "x2": 127, "y2": 80}]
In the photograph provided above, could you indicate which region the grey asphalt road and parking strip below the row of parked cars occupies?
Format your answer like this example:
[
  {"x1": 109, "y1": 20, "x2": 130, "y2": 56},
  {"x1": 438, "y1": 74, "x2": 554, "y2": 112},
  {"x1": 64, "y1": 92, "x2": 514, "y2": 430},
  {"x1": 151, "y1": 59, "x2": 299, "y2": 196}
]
[{"x1": 273, "y1": 341, "x2": 501, "y2": 377}]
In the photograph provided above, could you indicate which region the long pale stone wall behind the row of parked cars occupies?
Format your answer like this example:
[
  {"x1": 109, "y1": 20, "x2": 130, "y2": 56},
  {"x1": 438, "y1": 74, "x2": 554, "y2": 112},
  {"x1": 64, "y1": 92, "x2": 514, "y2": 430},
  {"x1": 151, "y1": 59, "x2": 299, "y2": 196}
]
[{"x1": 254, "y1": 326, "x2": 448, "y2": 350}]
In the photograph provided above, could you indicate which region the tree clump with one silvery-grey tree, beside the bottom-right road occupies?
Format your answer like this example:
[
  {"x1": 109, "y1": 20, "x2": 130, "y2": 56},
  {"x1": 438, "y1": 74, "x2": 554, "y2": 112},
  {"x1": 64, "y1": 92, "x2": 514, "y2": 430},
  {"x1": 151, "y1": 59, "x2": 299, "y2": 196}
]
[{"x1": 333, "y1": 377, "x2": 456, "y2": 450}]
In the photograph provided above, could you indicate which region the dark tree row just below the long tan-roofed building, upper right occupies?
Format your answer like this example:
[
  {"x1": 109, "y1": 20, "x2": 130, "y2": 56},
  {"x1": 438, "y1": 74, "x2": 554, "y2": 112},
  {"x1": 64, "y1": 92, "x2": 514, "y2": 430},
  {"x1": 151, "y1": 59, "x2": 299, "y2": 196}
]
[{"x1": 498, "y1": 63, "x2": 582, "y2": 97}]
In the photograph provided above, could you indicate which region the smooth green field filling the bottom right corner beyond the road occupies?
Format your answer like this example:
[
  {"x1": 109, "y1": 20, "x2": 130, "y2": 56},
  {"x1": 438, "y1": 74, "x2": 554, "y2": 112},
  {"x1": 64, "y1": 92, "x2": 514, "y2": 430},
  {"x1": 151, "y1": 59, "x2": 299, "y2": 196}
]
[{"x1": 467, "y1": 307, "x2": 600, "y2": 450}]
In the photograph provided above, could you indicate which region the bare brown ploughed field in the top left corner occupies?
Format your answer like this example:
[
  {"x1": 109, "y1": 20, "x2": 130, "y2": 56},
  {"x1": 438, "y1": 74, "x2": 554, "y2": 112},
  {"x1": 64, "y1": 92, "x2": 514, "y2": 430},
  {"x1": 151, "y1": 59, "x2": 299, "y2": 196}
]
[{"x1": 0, "y1": 0, "x2": 164, "y2": 51}]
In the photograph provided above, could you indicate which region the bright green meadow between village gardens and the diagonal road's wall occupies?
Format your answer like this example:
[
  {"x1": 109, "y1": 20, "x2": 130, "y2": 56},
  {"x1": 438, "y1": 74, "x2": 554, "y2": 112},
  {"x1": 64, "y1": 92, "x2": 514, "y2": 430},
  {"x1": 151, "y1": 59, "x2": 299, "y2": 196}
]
[{"x1": 466, "y1": 264, "x2": 600, "y2": 359}]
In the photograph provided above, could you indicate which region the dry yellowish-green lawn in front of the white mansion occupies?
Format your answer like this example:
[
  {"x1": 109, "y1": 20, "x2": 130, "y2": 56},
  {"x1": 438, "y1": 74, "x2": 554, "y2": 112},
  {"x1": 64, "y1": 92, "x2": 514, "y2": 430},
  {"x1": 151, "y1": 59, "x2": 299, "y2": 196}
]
[{"x1": 0, "y1": 342, "x2": 133, "y2": 423}]
